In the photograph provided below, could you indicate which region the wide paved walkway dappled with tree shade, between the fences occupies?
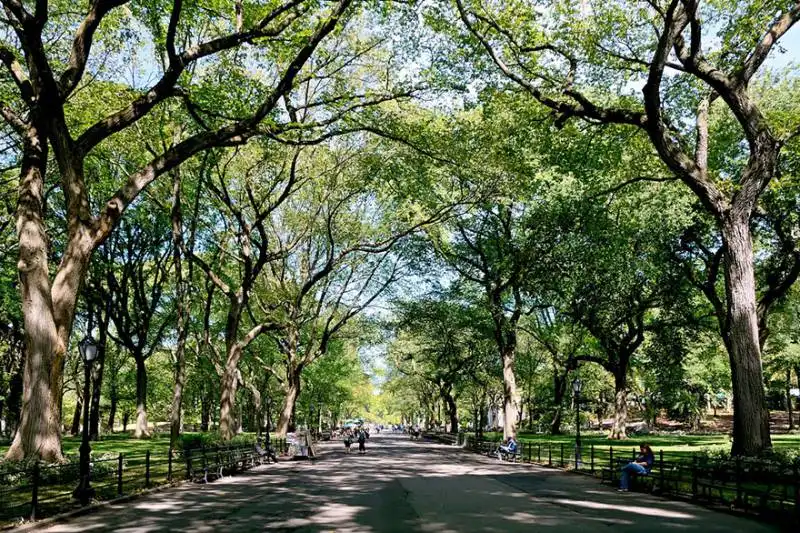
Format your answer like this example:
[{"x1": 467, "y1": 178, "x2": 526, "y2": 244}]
[{"x1": 29, "y1": 435, "x2": 775, "y2": 533}]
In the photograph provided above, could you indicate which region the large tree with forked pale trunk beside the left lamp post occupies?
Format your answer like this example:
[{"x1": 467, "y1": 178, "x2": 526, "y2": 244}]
[{"x1": 0, "y1": 0, "x2": 351, "y2": 461}]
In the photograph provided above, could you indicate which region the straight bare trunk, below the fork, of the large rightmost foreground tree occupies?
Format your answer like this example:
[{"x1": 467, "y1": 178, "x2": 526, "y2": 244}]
[{"x1": 722, "y1": 216, "x2": 772, "y2": 456}]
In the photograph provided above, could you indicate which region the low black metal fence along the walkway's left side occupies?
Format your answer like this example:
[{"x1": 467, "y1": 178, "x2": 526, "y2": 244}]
[{"x1": 0, "y1": 439, "x2": 288, "y2": 527}]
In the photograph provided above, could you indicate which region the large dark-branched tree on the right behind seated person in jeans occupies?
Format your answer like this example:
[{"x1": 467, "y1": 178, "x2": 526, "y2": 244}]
[{"x1": 456, "y1": 0, "x2": 800, "y2": 455}]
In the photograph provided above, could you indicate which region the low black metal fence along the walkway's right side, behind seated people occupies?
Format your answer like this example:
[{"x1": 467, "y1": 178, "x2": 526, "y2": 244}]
[{"x1": 437, "y1": 433, "x2": 800, "y2": 524}]
